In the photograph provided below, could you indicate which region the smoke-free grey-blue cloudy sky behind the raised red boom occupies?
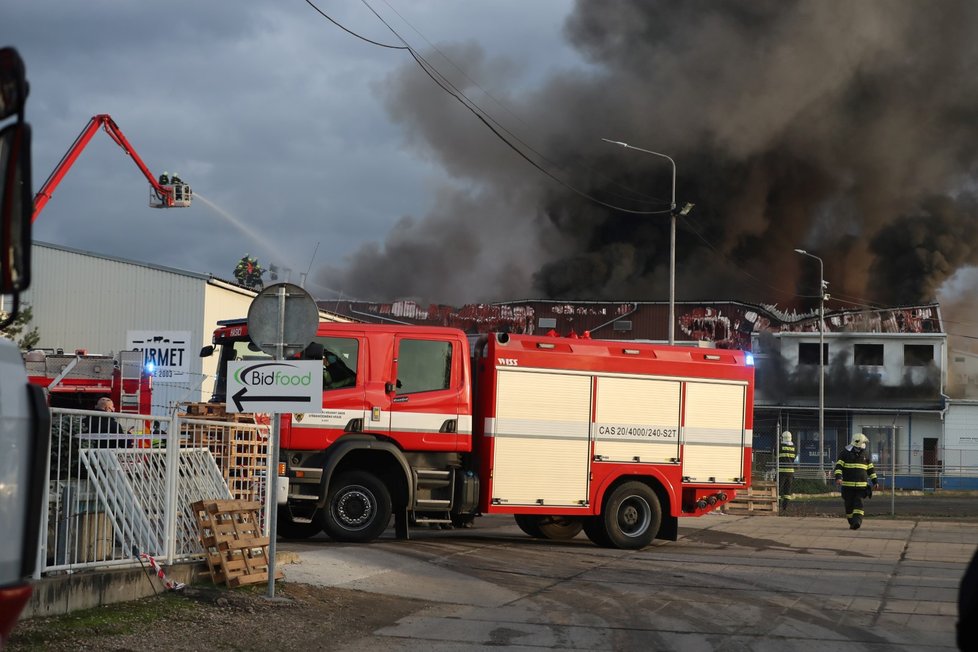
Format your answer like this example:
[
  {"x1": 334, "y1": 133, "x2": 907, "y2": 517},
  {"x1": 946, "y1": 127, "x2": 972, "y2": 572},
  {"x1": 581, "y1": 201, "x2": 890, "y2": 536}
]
[{"x1": 0, "y1": 0, "x2": 575, "y2": 293}]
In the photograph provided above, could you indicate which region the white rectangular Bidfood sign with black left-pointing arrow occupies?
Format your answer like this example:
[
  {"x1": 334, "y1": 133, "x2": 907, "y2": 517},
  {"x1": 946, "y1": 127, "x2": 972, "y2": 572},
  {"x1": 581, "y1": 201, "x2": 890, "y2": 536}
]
[{"x1": 227, "y1": 360, "x2": 323, "y2": 413}]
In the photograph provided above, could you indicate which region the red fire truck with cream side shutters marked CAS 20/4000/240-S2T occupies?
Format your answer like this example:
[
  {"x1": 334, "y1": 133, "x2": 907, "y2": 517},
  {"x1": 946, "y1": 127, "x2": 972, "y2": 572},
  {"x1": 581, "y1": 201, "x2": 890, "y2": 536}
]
[{"x1": 202, "y1": 320, "x2": 754, "y2": 549}]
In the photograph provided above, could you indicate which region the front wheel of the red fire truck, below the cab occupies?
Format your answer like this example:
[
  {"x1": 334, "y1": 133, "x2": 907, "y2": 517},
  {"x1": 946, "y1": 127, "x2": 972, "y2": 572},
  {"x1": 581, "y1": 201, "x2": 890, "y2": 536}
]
[{"x1": 324, "y1": 471, "x2": 391, "y2": 543}]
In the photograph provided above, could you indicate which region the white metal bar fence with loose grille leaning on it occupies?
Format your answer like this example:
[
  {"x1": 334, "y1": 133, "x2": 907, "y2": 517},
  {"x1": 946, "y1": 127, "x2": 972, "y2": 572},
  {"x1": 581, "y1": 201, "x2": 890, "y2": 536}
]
[{"x1": 36, "y1": 408, "x2": 270, "y2": 577}]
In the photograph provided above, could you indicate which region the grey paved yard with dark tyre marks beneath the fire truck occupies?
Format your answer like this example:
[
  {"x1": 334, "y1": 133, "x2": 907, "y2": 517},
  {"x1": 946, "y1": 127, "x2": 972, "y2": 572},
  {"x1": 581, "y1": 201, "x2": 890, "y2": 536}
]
[{"x1": 279, "y1": 512, "x2": 978, "y2": 652}]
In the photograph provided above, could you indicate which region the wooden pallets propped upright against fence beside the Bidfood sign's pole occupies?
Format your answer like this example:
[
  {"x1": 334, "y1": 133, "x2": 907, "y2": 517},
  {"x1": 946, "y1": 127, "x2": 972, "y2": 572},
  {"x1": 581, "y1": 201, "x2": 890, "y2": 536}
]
[{"x1": 193, "y1": 500, "x2": 284, "y2": 588}]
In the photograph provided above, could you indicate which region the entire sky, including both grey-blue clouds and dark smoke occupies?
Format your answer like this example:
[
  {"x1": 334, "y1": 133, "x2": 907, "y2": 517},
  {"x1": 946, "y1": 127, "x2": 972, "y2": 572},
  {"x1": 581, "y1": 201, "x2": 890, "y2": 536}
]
[{"x1": 0, "y1": 0, "x2": 978, "y2": 352}]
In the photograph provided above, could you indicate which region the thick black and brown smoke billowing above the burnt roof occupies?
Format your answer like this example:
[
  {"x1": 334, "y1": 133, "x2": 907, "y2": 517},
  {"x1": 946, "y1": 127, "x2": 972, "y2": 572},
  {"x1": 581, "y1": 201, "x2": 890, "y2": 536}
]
[{"x1": 319, "y1": 0, "x2": 978, "y2": 316}]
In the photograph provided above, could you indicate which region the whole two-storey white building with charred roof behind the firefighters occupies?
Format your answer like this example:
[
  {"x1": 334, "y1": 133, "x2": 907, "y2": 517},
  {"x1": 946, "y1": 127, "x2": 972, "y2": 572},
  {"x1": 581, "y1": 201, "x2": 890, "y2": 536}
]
[{"x1": 752, "y1": 305, "x2": 978, "y2": 490}]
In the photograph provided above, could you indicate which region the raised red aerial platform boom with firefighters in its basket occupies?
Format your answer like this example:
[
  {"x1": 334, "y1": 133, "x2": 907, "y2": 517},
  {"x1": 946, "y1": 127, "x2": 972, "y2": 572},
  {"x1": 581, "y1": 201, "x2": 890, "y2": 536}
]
[{"x1": 32, "y1": 113, "x2": 193, "y2": 221}]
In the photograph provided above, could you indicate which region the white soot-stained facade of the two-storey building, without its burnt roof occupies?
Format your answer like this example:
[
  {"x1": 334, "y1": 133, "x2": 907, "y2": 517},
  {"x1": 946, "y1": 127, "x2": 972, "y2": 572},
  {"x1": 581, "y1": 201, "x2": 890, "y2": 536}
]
[{"x1": 754, "y1": 324, "x2": 948, "y2": 488}]
